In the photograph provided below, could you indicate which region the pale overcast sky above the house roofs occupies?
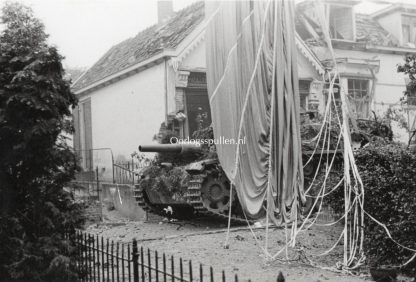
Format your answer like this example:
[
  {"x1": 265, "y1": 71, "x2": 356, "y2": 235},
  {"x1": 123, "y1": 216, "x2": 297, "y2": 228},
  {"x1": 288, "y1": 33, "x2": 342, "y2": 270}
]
[{"x1": 0, "y1": 0, "x2": 416, "y2": 68}]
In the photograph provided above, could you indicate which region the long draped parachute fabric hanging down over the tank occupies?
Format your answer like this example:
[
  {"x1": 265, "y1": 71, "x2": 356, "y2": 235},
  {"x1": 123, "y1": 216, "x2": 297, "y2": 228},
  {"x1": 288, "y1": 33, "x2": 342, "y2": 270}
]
[{"x1": 206, "y1": 0, "x2": 305, "y2": 222}]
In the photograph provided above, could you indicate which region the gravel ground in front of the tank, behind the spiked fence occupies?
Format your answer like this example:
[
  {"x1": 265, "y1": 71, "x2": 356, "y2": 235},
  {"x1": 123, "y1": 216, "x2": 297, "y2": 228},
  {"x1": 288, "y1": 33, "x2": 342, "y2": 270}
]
[{"x1": 87, "y1": 208, "x2": 371, "y2": 282}]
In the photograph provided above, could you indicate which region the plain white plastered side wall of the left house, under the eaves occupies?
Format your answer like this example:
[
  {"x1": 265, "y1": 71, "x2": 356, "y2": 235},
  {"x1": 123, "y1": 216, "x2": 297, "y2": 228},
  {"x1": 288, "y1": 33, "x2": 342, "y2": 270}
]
[{"x1": 80, "y1": 63, "x2": 165, "y2": 160}]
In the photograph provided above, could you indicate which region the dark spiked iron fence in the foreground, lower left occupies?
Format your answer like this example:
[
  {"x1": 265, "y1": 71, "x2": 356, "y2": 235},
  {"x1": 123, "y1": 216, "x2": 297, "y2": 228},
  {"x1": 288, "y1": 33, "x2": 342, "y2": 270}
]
[{"x1": 70, "y1": 231, "x2": 254, "y2": 282}]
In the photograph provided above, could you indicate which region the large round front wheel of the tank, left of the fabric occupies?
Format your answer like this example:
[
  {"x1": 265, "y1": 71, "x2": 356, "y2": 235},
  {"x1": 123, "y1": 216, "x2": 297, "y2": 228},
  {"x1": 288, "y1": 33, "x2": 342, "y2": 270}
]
[{"x1": 201, "y1": 175, "x2": 235, "y2": 213}]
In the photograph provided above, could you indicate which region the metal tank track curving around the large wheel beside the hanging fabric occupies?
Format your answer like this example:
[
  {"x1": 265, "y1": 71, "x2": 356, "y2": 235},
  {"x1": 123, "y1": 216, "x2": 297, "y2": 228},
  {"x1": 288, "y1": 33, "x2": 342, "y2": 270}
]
[{"x1": 186, "y1": 174, "x2": 257, "y2": 224}]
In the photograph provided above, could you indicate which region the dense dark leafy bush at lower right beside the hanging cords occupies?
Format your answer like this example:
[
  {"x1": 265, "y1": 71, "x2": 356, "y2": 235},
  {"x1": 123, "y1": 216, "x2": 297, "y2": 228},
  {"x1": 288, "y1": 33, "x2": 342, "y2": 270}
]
[{"x1": 328, "y1": 142, "x2": 416, "y2": 273}]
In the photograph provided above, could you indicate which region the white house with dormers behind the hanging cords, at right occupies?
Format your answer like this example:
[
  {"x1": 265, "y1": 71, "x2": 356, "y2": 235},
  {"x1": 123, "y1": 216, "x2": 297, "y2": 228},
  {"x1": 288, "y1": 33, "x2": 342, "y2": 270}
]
[{"x1": 296, "y1": 0, "x2": 416, "y2": 135}]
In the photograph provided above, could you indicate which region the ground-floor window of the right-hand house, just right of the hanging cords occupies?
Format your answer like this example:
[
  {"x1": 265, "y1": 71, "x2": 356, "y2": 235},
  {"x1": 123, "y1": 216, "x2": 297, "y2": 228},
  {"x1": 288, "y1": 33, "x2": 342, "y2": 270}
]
[{"x1": 348, "y1": 79, "x2": 370, "y2": 118}]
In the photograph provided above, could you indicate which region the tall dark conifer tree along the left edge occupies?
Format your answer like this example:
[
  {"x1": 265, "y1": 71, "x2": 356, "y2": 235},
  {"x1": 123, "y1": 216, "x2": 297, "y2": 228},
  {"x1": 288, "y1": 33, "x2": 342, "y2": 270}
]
[{"x1": 0, "y1": 3, "x2": 82, "y2": 281}]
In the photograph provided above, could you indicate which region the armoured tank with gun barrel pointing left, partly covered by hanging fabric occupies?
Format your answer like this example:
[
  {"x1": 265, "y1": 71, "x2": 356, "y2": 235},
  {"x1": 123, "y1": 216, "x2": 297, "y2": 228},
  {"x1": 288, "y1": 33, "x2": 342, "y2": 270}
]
[{"x1": 135, "y1": 112, "x2": 392, "y2": 223}]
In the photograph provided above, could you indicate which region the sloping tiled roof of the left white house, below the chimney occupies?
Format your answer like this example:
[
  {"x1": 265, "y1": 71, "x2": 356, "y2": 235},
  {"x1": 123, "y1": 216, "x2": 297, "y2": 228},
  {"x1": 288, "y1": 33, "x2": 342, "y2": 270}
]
[{"x1": 72, "y1": 2, "x2": 205, "y2": 91}]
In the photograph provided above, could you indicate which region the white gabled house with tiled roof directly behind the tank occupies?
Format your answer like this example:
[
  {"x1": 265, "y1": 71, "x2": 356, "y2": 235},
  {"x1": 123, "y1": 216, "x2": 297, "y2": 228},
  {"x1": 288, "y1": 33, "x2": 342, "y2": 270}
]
[{"x1": 73, "y1": 1, "x2": 324, "y2": 173}]
